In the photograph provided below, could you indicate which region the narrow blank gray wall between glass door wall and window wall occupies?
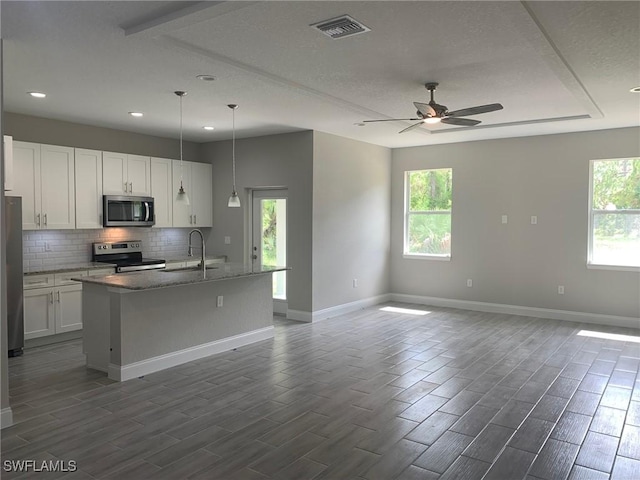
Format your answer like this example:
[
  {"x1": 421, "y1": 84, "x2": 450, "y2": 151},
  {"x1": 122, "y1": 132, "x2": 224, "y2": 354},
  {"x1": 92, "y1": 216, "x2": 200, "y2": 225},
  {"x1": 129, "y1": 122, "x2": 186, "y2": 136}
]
[{"x1": 313, "y1": 132, "x2": 391, "y2": 311}]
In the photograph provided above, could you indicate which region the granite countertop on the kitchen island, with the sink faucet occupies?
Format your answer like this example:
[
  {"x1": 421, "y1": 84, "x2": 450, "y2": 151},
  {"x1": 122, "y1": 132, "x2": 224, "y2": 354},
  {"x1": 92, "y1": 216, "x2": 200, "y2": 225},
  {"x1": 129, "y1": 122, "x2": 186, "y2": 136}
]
[{"x1": 73, "y1": 263, "x2": 290, "y2": 290}]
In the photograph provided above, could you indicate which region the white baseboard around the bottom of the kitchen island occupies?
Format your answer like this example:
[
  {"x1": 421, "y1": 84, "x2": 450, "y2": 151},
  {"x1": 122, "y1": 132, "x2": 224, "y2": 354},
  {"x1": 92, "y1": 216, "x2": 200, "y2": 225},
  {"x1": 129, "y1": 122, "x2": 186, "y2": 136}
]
[{"x1": 109, "y1": 326, "x2": 274, "y2": 382}]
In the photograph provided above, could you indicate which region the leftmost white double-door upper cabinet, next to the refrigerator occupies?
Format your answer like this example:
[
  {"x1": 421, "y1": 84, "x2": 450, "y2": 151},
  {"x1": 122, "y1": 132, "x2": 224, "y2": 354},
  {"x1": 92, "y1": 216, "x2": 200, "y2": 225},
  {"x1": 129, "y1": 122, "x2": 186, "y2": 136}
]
[{"x1": 12, "y1": 141, "x2": 76, "y2": 230}]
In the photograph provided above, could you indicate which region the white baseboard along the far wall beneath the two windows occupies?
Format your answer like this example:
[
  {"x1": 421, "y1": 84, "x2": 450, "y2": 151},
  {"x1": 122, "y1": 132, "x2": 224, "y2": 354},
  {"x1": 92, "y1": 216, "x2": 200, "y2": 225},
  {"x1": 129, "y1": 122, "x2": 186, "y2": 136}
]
[{"x1": 389, "y1": 293, "x2": 640, "y2": 328}]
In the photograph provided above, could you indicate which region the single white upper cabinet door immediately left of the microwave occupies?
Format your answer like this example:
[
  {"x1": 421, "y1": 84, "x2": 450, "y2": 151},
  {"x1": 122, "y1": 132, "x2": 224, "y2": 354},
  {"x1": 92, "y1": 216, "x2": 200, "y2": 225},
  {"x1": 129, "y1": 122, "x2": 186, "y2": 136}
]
[{"x1": 75, "y1": 148, "x2": 102, "y2": 228}]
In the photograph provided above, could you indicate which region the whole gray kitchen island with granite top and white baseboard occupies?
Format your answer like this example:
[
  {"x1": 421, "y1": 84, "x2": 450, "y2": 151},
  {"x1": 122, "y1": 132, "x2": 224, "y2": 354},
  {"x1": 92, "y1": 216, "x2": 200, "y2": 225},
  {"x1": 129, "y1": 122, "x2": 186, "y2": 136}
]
[{"x1": 77, "y1": 263, "x2": 287, "y2": 381}]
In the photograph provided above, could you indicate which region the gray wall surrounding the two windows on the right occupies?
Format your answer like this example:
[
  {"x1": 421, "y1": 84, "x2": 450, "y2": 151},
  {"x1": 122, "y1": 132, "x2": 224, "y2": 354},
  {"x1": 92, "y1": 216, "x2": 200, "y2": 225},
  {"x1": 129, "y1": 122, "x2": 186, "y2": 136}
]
[{"x1": 391, "y1": 128, "x2": 640, "y2": 317}]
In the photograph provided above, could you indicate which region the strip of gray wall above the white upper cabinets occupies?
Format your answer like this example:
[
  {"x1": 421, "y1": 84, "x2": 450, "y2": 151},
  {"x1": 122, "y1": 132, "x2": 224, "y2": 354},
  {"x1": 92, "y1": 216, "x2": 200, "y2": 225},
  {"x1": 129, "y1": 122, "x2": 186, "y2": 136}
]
[{"x1": 4, "y1": 112, "x2": 202, "y2": 162}]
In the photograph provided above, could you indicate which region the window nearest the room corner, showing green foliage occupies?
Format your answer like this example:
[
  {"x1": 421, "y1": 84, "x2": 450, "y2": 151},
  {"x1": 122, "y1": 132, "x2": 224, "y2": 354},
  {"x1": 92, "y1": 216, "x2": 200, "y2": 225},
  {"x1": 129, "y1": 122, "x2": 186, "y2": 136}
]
[{"x1": 404, "y1": 168, "x2": 453, "y2": 259}]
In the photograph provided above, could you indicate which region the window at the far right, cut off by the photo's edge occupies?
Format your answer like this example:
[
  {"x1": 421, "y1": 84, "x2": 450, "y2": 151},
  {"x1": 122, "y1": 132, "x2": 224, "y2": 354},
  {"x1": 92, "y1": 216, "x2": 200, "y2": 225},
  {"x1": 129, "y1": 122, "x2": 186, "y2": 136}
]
[{"x1": 588, "y1": 158, "x2": 640, "y2": 267}]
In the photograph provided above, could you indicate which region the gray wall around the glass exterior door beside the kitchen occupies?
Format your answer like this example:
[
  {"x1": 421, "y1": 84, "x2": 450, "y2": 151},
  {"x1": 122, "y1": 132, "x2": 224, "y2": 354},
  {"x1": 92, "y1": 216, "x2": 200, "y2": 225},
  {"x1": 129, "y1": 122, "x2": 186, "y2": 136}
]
[{"x1": 202, "y1": 132, "x2": 313, "y2": 312}]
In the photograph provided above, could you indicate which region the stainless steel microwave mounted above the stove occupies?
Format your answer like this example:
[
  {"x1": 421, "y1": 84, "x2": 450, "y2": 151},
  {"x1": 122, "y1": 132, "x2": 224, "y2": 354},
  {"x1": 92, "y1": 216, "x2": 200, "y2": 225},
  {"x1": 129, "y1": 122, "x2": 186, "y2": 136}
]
[{"x1": 102, "y1": 195, "x2": 156, "y2": 227}]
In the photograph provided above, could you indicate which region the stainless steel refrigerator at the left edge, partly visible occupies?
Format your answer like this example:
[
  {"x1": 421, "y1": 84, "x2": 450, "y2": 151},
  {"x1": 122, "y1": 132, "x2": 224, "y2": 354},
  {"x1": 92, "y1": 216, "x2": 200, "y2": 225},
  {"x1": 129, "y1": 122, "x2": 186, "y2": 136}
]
[{"x1": 5, "y1": 197, "x2": 24, "y2": 357}]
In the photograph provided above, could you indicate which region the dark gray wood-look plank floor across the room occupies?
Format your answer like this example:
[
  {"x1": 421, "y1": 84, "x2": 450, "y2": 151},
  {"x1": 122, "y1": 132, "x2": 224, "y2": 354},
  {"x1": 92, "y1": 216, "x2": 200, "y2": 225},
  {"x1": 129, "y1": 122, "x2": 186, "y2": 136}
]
[{"x1": 2, "y1": 304, "x2": 640, "y2": 480}]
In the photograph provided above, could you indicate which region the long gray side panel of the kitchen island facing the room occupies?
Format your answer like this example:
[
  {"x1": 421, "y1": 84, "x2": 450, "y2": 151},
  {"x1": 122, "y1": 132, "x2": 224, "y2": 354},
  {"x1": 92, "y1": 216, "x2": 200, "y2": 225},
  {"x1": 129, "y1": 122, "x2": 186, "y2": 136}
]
[{"x1": 110, "y1": 274, "x2": 273, "y2": 379}]
